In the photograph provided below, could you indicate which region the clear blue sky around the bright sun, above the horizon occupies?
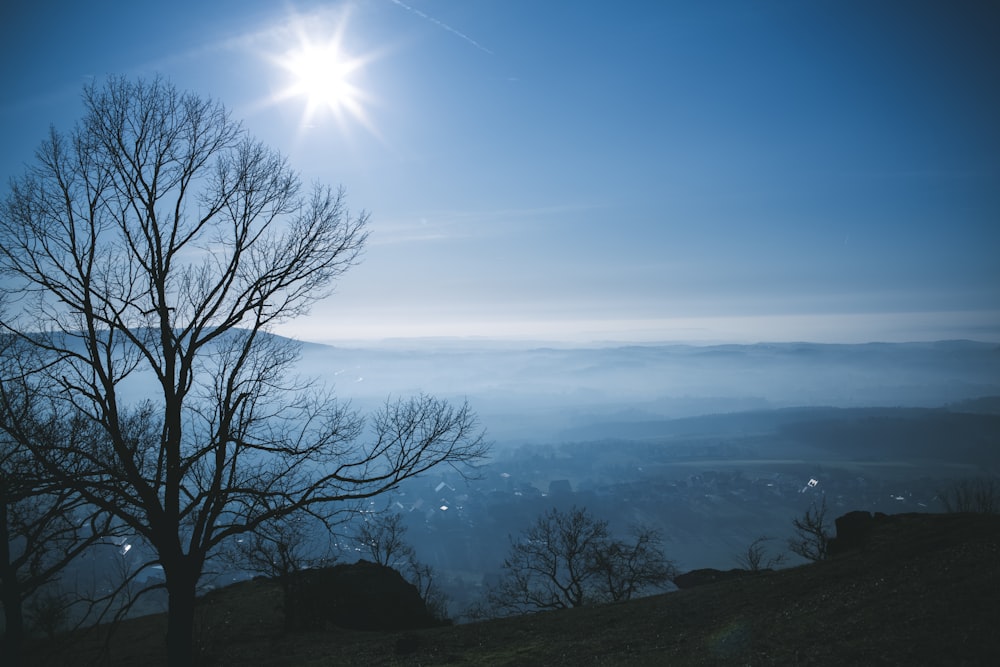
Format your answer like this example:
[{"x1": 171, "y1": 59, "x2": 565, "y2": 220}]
[{"x1": 0, "y1": 0, "x2": 1000, "y2": 342}]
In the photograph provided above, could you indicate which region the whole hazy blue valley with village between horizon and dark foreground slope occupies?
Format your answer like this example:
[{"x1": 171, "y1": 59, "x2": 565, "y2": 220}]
[{"x1": 64, "y1": 340, "x2": 1000, "y2": 619}]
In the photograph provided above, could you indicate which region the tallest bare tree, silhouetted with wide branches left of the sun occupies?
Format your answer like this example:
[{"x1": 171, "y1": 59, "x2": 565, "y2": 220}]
[{"x1": 0, "y1": 78, "x2": 485, "y2": 665}]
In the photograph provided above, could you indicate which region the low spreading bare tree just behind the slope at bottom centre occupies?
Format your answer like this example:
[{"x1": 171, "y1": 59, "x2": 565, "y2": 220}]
[{"x1": 488, "y1": 507, "x2": 674, "y2": 613}]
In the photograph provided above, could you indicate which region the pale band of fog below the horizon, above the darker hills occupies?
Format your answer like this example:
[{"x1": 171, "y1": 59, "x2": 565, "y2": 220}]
[{"x1": 299, "y1": 340, "x2": 1000, "y2": 446}]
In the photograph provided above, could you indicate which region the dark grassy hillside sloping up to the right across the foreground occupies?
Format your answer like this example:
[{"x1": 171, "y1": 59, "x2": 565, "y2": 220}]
[{"x1": 36, "y1": 514, "x2": 1000, "y2": 667}]
